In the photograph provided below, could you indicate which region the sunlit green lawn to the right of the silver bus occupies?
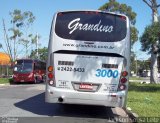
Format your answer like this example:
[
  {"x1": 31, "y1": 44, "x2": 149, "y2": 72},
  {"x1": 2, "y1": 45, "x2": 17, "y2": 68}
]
[{"x1": 127, "y1": 83, "x2": 160, "y2": 117}]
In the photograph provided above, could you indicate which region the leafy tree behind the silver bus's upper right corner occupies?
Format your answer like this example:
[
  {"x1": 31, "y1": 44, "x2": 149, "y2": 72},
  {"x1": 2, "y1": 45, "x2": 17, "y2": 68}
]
[{"x1": 99, "y1": 0, "x2": 138, "y2": 46}]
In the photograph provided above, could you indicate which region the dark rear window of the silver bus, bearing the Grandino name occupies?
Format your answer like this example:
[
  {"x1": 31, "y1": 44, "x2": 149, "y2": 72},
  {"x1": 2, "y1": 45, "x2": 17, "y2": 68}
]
[{"x1": 55, "y1": 11, "x2": 127, "y2": 42}]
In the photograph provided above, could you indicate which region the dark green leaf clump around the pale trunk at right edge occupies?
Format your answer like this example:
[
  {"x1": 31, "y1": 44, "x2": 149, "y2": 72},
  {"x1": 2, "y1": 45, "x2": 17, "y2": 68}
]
[{"x1": 140, "y1": 22, "x2": 160, "y2": 53}]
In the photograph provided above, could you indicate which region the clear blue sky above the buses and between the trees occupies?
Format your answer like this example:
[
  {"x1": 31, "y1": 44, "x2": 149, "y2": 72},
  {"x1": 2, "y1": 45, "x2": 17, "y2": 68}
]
[{"x1": 0, "y1": 0, "x2": 160, "y2": 60}]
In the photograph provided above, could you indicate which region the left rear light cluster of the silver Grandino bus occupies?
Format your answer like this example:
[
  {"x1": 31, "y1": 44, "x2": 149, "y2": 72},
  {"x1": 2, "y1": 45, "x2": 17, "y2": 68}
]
[{"x1": 48, "y1": 66, "x2": 54, "y2": 86}]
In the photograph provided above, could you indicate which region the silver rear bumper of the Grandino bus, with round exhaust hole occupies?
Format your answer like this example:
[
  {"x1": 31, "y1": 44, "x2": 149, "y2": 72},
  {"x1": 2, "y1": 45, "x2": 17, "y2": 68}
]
[{"x1": 45, "y1": 86, "x2": 126, "y2": 107}]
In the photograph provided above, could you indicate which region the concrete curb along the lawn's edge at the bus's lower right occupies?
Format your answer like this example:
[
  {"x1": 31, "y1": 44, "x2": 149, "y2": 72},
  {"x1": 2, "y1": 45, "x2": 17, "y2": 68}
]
[{"x1": 124, "y1": 107, "x2": 138, "y2": 123}]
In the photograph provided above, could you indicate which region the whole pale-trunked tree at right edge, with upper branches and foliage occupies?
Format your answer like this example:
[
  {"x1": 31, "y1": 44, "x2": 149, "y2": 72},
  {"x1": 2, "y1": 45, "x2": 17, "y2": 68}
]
[{"x1": 140, "y1": 0, "x2": 160, "y2": 83}]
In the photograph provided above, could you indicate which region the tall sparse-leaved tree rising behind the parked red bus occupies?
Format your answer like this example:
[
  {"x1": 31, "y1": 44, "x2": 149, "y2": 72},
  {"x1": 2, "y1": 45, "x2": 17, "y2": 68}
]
[{"x1": 9, "y1": 10, "x2": 35, "y2": 60}]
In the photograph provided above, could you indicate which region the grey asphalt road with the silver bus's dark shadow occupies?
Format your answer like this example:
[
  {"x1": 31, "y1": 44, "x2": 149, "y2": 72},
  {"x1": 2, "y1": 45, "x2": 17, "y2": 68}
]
[{"x1": 0, "y1": 84, "x2": 128, "y2": 123}]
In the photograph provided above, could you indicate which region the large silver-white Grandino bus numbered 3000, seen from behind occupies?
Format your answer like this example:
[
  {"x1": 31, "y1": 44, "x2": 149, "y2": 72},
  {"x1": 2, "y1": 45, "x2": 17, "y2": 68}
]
[{"x1": 45, "y1": 10, "x2": 130, "y2": 107}]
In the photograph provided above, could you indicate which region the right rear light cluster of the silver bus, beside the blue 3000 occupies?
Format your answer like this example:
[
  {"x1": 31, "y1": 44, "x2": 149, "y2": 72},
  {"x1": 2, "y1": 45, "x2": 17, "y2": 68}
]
[{"x1": 118, "y1": 71, "x2": 128, "y2": 91}]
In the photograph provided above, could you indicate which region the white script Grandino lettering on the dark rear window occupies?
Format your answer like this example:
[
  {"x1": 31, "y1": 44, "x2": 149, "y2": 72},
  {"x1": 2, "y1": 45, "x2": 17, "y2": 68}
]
[{"x1": 68, "y1": 18, "x2": 113, "y2": 34}]
